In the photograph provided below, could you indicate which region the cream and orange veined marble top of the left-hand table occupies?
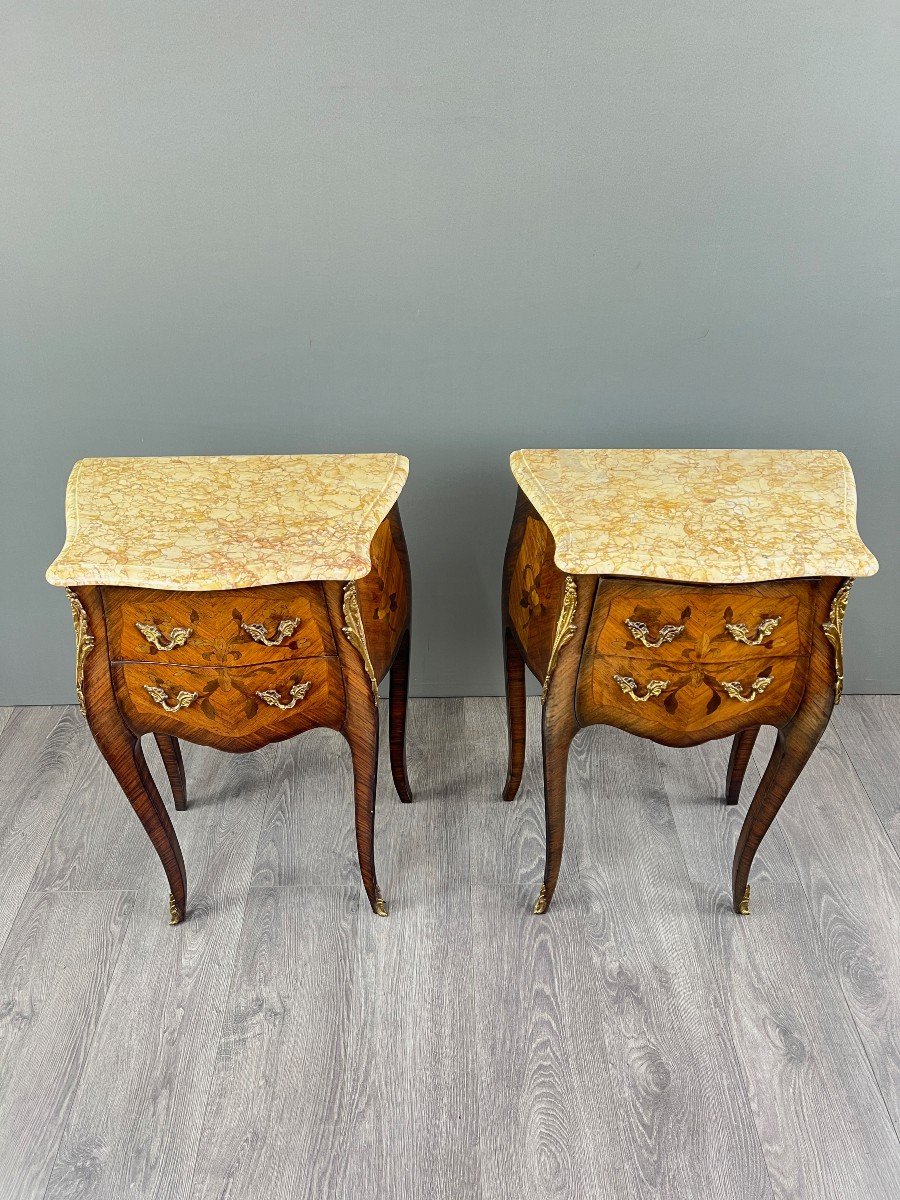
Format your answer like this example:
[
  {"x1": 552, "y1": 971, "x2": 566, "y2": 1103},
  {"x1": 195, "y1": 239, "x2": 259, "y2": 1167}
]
[{"x1": 47, "y1": 454, "x2": 409, "y2": 592}]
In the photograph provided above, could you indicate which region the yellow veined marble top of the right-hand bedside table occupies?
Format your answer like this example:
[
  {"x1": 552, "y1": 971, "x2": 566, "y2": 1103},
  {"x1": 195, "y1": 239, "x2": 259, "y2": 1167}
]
[{"x1": 510, "y1": 450, "x2": 878, "y2": 583}]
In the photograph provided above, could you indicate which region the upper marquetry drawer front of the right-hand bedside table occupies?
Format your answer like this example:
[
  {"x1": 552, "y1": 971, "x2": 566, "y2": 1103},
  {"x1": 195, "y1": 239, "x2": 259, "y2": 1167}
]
[{"x1": 588, "y1": 580, "x2": 812, "y2": 662}]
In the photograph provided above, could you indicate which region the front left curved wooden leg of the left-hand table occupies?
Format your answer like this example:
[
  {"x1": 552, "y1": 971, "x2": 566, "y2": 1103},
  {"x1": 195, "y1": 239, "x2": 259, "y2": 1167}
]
[{"x1": 88, "y1": 710, "x2": 187, "y2": 925}]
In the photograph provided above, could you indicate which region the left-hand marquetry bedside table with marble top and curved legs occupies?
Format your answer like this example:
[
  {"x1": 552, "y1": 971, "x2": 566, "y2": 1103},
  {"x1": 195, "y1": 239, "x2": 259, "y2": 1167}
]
[{"x1": 47, "y1": 454, "x2": 410, "y2": 924}]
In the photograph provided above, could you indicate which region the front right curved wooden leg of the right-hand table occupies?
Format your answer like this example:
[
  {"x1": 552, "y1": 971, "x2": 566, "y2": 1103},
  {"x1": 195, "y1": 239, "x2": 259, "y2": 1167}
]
[{"x1": 732, "y1": 709, "x2": 830, "y2": 917}]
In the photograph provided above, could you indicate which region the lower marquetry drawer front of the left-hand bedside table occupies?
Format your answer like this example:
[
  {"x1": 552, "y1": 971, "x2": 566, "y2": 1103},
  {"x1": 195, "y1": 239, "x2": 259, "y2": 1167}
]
[{"x1": 112, "y1": 658, "x2": 344, "y2": 750}]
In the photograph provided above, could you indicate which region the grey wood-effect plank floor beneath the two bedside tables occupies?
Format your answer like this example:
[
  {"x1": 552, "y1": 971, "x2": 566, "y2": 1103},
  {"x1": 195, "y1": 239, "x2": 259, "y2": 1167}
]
[{"x1": 0, "y1": 697, "x2": 900, "y2": 1200}]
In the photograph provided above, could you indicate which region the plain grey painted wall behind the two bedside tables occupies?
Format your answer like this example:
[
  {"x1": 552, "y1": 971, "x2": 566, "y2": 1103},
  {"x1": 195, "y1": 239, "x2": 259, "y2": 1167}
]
[{"x1": 0, "y1": 0, "x2": 900, "y2": 703}]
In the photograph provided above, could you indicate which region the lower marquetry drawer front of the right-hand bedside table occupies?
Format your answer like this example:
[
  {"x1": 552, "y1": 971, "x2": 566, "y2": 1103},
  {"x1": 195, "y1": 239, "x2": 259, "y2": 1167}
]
[{"x1": 577, "y1": 655, "x2": 809, "y2": 744}]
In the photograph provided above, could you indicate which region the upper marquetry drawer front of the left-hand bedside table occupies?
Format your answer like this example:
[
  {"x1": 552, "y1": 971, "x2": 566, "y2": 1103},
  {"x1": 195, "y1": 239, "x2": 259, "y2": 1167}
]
[{"x1": 103, "y1": 583, "x2": 336, "y2": 666}]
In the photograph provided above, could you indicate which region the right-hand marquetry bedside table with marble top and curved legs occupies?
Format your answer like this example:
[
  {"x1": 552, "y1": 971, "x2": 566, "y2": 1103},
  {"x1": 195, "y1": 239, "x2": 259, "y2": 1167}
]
[{"x1": 503, "y1": 450, "x2": 878, "y2": 914}]
